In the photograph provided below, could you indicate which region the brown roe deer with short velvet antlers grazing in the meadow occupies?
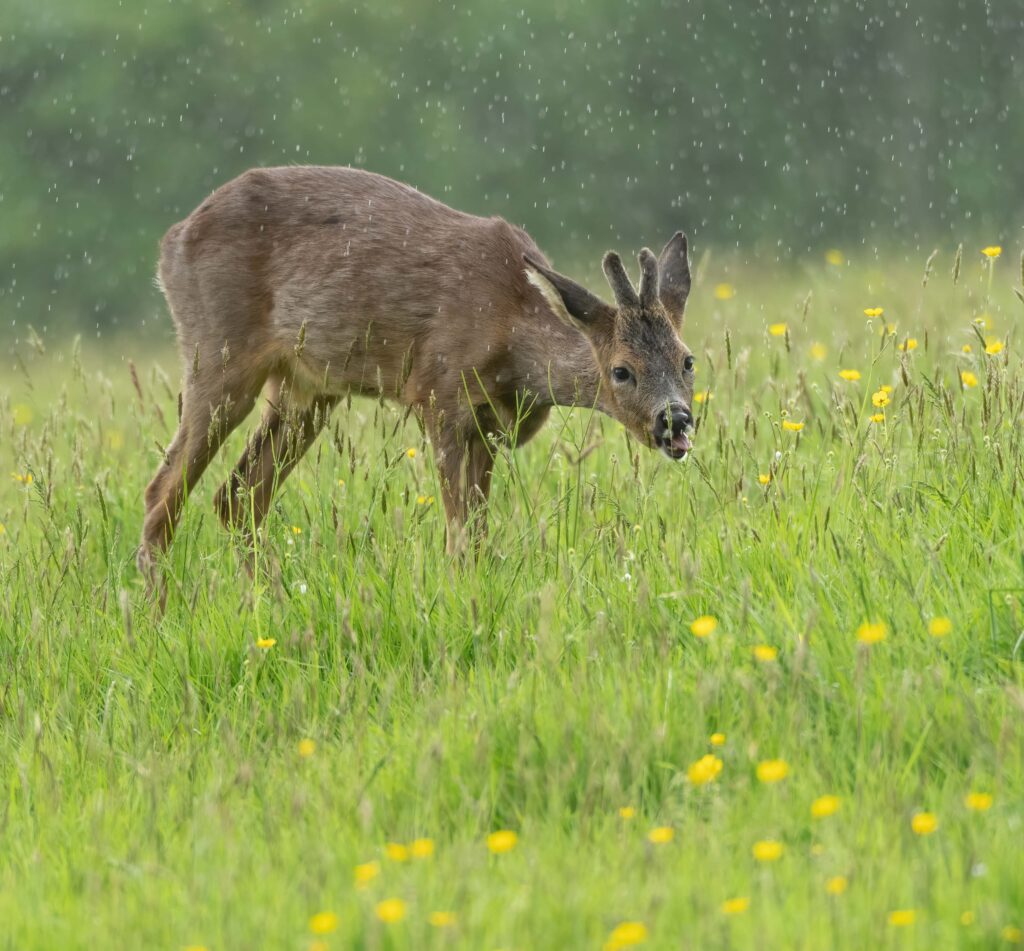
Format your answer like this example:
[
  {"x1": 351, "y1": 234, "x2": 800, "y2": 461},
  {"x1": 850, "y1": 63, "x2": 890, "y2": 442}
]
[{"x1": 138, "y1": 167, "x2": 693, "y2": 587}]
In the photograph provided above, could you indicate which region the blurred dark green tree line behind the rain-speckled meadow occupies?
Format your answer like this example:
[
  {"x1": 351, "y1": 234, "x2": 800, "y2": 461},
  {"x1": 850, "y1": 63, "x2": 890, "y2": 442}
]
[{"x1": 0, "y1": 0, "x2": 1024, "y2": 333}]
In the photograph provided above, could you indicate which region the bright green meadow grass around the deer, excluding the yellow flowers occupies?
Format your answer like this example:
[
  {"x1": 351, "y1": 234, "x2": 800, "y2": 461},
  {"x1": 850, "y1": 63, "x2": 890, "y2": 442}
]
[{"x1": 0, "y1": 249, "x2": 1024, "y2": 949}]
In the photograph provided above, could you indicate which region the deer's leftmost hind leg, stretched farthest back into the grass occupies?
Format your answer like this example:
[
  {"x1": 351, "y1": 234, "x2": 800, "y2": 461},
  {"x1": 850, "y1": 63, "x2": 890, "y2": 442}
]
[{"x1": 136, "y1": 366, "x2": 265, "y2": 606}]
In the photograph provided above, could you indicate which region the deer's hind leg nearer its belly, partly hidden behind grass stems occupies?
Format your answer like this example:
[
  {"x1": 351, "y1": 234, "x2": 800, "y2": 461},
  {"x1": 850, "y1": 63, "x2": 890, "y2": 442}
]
[{"x1": 214, "y1": 388, "x2": 335, "y2": 547}]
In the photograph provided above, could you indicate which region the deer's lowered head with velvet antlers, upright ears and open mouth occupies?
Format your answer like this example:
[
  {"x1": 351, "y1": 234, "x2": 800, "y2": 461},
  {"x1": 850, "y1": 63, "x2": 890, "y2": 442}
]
[{"x1": 523, "y1": 231, "x2": 693, "y2": 459}]
